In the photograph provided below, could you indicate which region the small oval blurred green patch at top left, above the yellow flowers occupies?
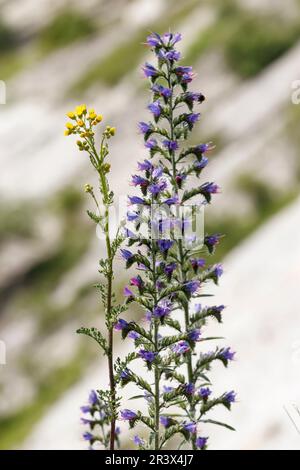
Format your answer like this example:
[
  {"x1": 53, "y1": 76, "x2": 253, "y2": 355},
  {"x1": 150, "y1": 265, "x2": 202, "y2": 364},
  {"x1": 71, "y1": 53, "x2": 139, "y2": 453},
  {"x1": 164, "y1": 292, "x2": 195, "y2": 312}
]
[{"x1": 40, "y1": 8, "x2": 97, "y2": 52}]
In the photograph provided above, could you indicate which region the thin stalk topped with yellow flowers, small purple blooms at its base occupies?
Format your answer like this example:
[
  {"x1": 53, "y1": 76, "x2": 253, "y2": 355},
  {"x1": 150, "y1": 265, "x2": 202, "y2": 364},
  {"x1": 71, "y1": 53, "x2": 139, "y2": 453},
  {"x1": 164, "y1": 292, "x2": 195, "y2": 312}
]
[{"x1": 65, "y1": 105, "x2": 126, "y2": 450}]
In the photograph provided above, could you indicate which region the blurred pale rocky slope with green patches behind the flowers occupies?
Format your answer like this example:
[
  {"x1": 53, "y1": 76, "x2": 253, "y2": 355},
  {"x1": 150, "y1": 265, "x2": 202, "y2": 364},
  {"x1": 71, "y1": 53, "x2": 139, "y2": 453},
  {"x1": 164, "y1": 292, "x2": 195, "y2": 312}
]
[{"x1": 0, "y1": 0, "x2": 300, "y2": 449}]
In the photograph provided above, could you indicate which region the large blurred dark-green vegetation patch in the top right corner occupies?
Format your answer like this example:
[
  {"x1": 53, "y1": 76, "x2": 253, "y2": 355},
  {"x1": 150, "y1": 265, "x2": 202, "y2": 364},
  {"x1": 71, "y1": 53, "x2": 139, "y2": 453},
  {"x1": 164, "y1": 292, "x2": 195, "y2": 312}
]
[{"x1": 185, "y1": 0, "x2": 300, "y2": 78}]
